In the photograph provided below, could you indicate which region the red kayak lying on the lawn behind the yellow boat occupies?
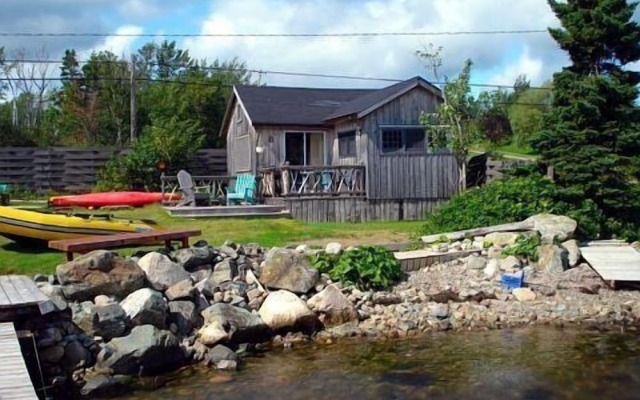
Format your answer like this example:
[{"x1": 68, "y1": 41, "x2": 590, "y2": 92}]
[{"x1": 49, "y1": 192, "x2": 180, "y2": 208}]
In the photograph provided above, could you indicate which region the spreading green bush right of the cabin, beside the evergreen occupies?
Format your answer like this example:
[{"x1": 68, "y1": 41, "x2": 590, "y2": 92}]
[{"x1": 419, "y1": 174, "x2": 604, "y2": 238}]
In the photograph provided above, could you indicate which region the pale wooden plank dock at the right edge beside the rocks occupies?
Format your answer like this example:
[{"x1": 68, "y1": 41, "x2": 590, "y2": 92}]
[{"x1": 580, "y1": 243, "x2": 640, "y2": 286}]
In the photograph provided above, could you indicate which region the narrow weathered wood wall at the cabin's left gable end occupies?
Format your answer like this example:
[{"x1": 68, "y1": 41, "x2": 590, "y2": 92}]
[{"x1": 227, "y1": 101, "x2": 255, "y2": 175}]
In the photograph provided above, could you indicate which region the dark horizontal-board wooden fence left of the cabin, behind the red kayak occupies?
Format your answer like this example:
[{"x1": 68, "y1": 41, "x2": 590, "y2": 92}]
[{"x1": 0, "y1": 147, "x2": 227, "y2": 193}]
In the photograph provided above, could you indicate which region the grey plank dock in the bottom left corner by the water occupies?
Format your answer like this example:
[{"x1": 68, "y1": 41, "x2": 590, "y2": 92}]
[{"x1": 0, "y1": 324, "x2": 38, "y2": 400}]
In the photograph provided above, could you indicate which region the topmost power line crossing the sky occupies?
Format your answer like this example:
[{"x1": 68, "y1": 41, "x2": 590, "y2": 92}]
[{"x1": 0, "y1": 29, "x2": 548, "y2": 38}]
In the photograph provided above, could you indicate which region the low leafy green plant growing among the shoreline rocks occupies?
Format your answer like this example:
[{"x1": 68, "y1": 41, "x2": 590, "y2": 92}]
[{"x1": 311, "y1": 246, "x2": 403, "y2": 290}]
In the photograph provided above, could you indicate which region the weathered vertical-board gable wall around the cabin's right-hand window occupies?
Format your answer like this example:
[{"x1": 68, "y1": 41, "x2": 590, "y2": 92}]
[{"x1": 361, "y1": 87, "x2": 457, "y2": 200}]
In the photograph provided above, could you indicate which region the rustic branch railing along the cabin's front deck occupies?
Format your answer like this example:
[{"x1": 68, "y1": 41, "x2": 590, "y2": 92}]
[{"x1": 276, "y1": 165, "x2": 366, "y2": 197}]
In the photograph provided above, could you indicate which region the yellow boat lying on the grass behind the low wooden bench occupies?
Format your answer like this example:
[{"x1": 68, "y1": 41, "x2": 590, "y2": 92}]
[{"x1": 0, "y1": 206, "x2": 155, "y2": 243}]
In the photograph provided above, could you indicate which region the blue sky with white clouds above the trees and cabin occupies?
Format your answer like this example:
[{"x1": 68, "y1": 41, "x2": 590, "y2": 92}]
[{"x1": 0, "y1": 0, "x2": 639, "y2": 87}]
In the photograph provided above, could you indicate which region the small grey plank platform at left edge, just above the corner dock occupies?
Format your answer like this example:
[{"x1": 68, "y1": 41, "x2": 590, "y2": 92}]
[{"x1": 0, "y1": 275, "x2": 53, "y2": 322}]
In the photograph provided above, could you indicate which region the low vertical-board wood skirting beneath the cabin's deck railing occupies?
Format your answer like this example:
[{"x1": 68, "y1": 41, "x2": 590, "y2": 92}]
[{"x1": 284, "y1": 197, "x2": 445, "y2": 223}]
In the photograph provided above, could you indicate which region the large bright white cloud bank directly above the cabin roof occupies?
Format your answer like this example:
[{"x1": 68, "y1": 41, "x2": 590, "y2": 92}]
[{"x1": 182, "y1": 0, "x2": 565, "y2": 86}]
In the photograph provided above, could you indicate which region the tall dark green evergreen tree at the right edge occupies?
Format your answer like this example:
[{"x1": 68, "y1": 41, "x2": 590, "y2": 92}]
[{"x1": 532, "y1": 0, "x2": 640, "y2": 236}]
